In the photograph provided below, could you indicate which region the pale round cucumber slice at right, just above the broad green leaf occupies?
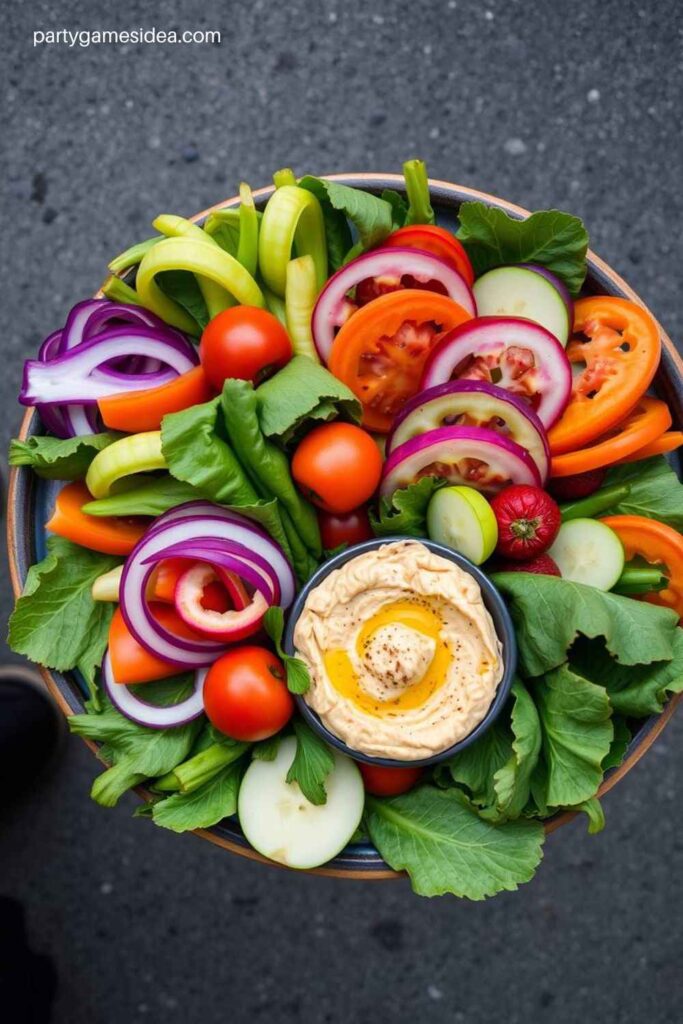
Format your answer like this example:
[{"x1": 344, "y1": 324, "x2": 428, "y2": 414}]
[{"x1": 548, "y1": 519, "x2": 624, "y2": 590}]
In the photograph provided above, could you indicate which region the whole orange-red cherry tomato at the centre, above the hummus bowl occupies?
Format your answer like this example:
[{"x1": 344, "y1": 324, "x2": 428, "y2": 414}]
[{"x1": 292, "y1": 423, "x2": 382, "y2": 515}]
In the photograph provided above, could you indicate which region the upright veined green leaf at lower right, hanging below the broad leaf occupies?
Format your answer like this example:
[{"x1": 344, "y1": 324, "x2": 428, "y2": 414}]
[{"x1": 535, "y1": 666, "x2": 614, "y2": 807}]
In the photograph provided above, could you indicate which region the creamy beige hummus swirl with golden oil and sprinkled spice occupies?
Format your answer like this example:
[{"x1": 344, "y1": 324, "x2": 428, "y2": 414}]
[{"x1": 294, "y1": 541, "x2": 503, "y2": 761}]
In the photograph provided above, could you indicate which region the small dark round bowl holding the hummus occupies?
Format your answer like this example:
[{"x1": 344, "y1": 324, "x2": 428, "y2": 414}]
[{"x1": 283, "y1": 537, "x2": 517, "y2": 768}]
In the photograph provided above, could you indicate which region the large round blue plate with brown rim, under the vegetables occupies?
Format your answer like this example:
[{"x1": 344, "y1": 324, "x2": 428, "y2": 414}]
[{"x1": 7, "y1": 173, "x2": 683, "y2": 880}]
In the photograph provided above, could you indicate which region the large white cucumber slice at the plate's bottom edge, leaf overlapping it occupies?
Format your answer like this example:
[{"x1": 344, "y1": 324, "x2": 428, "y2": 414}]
[{"x1": 238, "y1": 736, "x2": 365, "y2": 869}]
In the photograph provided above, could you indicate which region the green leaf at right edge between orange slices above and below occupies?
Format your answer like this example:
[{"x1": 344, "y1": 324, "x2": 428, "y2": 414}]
[{"x1": 598, "y1": 455, "x2": 683, "y2": 531}]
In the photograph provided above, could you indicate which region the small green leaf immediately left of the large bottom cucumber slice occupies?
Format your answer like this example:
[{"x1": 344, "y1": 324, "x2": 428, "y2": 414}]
[{"x1": 152, "y1": 764, "x2": 242, "y2": 833}]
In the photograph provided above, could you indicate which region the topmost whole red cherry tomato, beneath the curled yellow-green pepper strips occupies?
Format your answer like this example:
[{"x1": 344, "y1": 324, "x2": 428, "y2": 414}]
[{"x1": 200, "y1": 306, "x2": 292, "y2": 391}]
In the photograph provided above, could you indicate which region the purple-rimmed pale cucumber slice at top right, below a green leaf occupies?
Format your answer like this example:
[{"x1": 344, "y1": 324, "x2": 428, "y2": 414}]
[{"x1": 473, "y1": 266, "x2": 572, "y2": 345}]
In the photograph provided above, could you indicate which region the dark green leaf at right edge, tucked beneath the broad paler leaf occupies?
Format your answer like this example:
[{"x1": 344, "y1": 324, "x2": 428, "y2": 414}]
[{"x1": 570, "y1": 626, "x2": 683, "y2": 718}]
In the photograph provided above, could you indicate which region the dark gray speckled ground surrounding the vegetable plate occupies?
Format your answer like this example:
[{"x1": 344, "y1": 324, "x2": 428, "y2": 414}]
[{"x1": 0, "y1": 0, "x2": 683, "y2": 1024}]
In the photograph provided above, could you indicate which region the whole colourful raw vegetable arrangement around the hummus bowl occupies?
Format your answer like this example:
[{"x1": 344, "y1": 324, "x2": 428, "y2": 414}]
[{"x1": 9, "y1": 155, "x2": 683, "y2": 899}]
